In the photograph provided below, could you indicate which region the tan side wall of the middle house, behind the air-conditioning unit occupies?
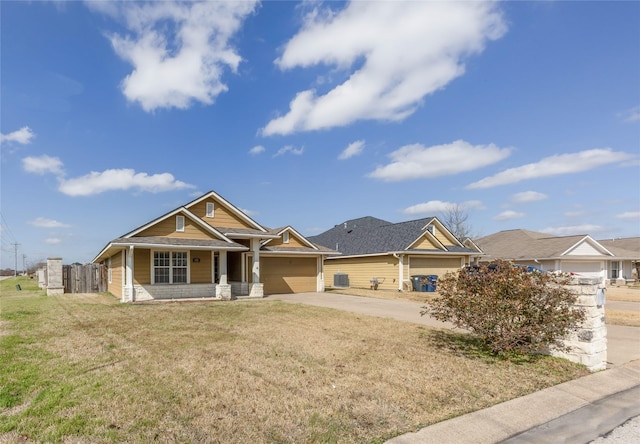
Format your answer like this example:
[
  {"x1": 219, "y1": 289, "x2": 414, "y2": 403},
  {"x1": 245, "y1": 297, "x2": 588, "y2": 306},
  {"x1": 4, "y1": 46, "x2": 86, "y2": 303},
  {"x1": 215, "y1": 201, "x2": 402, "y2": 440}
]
[{"x1": 324, "y1": 255, "x2": 398, "y2": 290}]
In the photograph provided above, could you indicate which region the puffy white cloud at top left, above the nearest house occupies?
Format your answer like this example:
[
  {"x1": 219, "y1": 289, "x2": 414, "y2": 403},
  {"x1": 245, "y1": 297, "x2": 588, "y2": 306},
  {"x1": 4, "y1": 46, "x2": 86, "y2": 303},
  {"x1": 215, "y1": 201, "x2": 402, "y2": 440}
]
[{"x1": 102, "y1": 1, "x2": 256, "y2": 111}]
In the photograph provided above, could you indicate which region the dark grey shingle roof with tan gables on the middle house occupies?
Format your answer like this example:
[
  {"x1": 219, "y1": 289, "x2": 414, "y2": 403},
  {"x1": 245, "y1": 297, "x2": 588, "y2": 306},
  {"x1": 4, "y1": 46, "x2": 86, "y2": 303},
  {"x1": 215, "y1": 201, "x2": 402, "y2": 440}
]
[{"x1": 309, "y1": 216, "x2": 473, "y2": 256}]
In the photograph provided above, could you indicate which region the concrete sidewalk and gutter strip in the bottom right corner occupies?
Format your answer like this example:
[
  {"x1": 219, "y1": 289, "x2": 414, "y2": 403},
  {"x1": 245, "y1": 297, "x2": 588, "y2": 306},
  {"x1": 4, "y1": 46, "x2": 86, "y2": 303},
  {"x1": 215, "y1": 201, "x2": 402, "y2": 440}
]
[{"x1": 387, "y1": 360, "x2": 640, "y2": 444}]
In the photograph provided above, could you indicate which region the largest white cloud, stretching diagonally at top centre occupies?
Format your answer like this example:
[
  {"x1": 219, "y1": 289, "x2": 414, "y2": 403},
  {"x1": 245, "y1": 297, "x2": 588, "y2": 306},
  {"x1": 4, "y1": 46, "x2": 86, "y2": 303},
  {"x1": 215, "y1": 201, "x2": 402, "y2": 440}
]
[{"x1": 262, "y1": 1, "x2": 506, "y2": 135}]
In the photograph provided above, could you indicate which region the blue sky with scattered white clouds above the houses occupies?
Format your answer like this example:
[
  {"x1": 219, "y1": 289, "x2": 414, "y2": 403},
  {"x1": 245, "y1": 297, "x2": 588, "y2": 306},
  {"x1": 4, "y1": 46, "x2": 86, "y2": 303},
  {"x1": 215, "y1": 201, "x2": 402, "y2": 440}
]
[{"x1": 0, "y1": 1, "x2": 640, "y2": 268}]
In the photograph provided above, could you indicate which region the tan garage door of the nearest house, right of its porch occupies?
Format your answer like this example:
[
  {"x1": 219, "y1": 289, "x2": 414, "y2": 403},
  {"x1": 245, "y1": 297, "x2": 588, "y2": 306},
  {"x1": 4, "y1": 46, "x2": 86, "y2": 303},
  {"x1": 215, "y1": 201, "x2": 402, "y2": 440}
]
[{"x1": 260, "y1": 257, "x2": 318, "y2": 294}]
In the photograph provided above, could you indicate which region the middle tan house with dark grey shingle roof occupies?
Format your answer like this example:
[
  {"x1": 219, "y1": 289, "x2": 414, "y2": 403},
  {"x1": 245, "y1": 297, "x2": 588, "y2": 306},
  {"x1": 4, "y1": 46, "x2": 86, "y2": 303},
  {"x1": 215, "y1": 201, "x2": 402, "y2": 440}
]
[{"x1": 309, "y1": 217, "x2": 482, "y2": 291}]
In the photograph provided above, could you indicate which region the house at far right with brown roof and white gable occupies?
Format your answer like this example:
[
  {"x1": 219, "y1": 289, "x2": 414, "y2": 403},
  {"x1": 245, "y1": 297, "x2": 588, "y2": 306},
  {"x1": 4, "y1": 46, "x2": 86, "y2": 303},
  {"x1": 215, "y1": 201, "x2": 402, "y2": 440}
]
[{"x1": 465, "y1": 229, "x2": 640, "y2": 282}]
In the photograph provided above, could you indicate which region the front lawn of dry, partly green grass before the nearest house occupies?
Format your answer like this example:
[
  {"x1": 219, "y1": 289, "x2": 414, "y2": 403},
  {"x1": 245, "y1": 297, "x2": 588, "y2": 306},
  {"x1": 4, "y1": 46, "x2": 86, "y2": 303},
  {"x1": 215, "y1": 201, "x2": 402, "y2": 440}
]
[{"x1": 0, "y1": 282, "x2": 587, "y2": 443}]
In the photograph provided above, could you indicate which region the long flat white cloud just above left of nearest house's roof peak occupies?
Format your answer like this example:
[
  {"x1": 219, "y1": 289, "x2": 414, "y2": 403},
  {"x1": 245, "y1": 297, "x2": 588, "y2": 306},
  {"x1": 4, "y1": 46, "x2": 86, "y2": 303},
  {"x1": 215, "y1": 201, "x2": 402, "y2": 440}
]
[{"x1": 58, "y1": 169, "x2": 195, "y2": 196}]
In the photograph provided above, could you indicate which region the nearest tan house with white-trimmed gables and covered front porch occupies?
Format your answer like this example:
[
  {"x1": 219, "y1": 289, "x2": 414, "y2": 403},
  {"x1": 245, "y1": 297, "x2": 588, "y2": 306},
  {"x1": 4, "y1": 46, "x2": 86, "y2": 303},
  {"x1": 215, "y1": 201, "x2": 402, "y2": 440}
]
[{"x1": 93, "y1": 191, "x2": 336, "y2": 302}]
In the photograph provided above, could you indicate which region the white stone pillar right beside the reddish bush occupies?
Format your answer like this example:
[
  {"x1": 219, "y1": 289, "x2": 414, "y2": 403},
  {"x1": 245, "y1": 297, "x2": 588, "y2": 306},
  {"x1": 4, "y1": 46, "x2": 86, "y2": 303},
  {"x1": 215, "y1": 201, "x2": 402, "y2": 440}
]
[{"x1": 551, "y1": 278, "x2": 607, "y2": 372}]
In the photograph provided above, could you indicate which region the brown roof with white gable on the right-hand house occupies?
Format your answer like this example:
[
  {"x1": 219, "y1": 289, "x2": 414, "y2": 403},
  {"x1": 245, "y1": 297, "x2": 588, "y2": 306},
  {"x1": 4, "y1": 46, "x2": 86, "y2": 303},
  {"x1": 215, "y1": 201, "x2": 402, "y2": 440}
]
[{"x1": 473, "y1": 229, "x2": 613, "y2": 259}]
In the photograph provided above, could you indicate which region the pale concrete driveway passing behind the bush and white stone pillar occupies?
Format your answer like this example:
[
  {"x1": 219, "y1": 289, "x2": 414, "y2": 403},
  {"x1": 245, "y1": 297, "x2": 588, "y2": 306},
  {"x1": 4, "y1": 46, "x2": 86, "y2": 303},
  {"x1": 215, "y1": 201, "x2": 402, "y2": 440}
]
[{"x1": 266, "y1": 293, "x2": 640, "y2": 366}]
